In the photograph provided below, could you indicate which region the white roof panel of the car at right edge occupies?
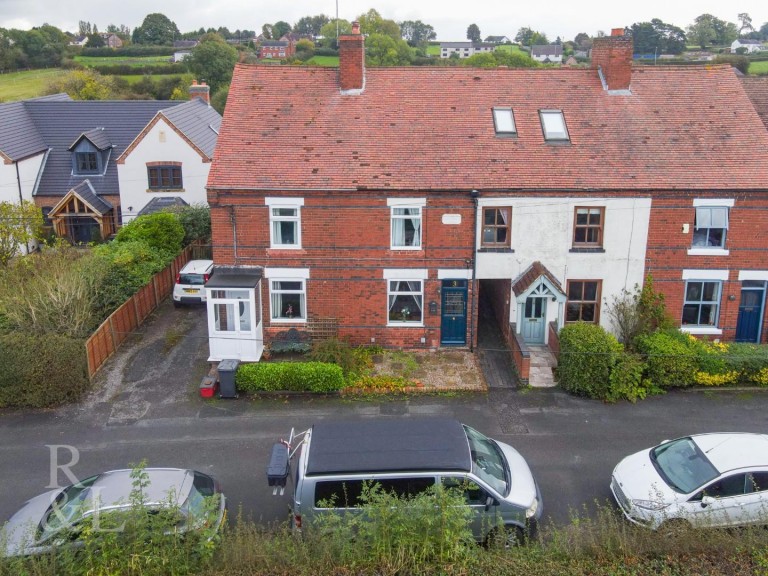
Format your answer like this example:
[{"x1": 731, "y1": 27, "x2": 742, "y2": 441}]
[{"x1": 691, "y1": 432, "x2": 768, "y2": 473}]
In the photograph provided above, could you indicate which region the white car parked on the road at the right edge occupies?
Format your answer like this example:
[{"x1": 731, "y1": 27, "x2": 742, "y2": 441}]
[{"x1": 611, "y1": 433, "x2": 768, "y2": 529}]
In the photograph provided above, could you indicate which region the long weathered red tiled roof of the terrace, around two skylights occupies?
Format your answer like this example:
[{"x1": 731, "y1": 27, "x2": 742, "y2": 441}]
[{"x1": 208, "y1": 64, "x2": 768, "y2": 190}]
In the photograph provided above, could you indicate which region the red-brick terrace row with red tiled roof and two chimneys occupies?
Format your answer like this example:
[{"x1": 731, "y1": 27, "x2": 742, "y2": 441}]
[{"x1": 208, "y1": 24, "x2": 768, "y2": 360}]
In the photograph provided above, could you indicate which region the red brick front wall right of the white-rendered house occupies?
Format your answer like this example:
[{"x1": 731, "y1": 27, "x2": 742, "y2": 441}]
[{"x1": 646, "y1": 192, "x2": 768, "y2": 342}]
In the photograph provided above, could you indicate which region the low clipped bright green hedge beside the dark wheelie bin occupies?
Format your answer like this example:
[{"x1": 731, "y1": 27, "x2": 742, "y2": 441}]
[{"x1": 235, "y1": 362, "x2": 346, "y2": 392}]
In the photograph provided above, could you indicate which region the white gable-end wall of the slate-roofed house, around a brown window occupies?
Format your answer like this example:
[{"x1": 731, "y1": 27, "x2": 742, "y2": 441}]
[{"x1": 117, "y1": 119, "x2": 211, "y2": 223}]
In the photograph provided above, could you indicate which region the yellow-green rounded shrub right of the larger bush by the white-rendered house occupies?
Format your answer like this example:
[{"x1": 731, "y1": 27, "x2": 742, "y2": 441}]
[{"x1": 635, "y1": 331, "x2": 698, "y2": 388}]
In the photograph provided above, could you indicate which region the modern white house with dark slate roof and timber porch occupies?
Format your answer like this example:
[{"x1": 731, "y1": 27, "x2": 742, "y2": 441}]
[{"x1": 0, "y1": 84, "x2": 221, "y2": 248}]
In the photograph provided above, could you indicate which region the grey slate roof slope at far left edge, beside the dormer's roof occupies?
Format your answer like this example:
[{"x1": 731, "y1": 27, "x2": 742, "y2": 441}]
[{"x1": 0, "y1": 94, "x2": 70, "y2": 161}]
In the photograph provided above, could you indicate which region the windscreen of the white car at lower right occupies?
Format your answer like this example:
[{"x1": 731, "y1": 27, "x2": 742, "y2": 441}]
[{"x1": 650, "y1": 438, "x2": 720, "y2": 494}]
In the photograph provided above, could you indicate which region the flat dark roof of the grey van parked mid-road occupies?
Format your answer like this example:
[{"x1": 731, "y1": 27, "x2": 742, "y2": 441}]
[{"x1": 306, "y1": 418, "x2": 472, "y2": 476}]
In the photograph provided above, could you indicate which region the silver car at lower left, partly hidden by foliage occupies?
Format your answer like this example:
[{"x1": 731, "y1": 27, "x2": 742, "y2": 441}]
[{"x1": 0, "y1": 468, "x2": 226, "y2": 557}]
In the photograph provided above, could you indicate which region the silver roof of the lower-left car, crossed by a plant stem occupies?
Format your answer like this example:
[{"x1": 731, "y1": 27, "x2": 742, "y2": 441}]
[{"x1": 87, "y1": 468, "x2": 194, "y2": 508}]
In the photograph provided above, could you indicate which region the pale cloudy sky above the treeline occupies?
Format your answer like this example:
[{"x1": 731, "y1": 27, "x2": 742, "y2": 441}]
[{"x1": 0, "y1": 0, "x2": 768, "y2": 41}]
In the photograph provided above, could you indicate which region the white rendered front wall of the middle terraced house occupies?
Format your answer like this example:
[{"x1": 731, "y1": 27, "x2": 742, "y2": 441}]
[{"x1": 476, "y1": 198, "x2": 651, "y2": 330}]
